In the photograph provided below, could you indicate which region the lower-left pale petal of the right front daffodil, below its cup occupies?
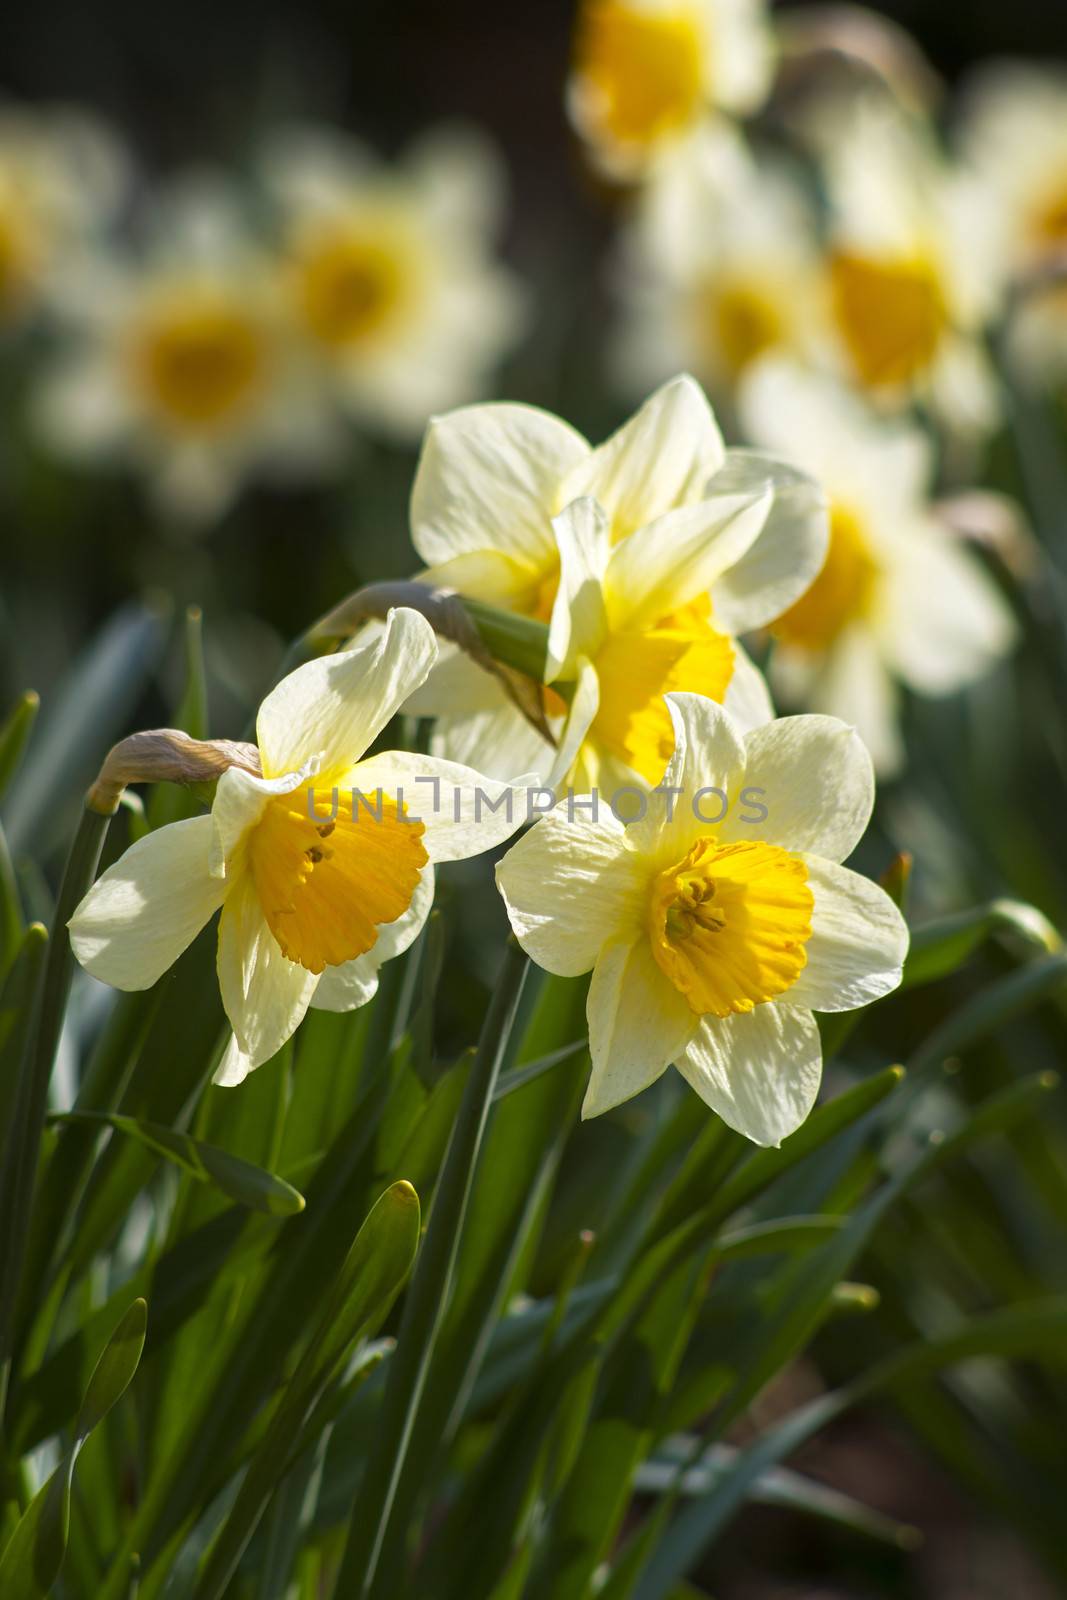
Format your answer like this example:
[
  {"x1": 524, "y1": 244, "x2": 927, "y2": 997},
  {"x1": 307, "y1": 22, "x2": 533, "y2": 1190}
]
[{"x1": 582, "y1": 934, "x2": 699, "y2": 1117}]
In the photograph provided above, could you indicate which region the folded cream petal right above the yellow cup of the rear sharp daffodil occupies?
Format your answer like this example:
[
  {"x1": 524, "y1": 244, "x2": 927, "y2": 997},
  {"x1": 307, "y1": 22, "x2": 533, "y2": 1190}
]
[{"x1": 605, "y1": 485, "x2": 773, "y2": 627}]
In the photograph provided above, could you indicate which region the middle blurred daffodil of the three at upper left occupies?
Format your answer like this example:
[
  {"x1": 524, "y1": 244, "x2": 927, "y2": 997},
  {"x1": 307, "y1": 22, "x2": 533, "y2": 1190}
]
[{"x1": 37, "y1": 176, "x2": 339, "y2": 522}]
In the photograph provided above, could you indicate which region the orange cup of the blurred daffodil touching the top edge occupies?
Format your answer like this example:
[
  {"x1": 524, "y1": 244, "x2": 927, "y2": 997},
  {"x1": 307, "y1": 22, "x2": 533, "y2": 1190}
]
[{"x1": 576, "y1": 0, "x2": 704, "y2": 146}]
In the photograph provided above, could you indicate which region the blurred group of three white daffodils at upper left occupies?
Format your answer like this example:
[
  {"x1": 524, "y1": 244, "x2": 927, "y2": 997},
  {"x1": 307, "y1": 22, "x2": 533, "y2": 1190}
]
[{"x1": 0, "y1": 100, "x2": 525, "y2": 523}]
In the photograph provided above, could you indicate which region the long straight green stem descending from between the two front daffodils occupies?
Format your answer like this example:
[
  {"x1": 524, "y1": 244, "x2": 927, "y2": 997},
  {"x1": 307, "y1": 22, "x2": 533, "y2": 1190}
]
[{"x1": 334, "y1": 939, "x2": 528, "y2": 1600}]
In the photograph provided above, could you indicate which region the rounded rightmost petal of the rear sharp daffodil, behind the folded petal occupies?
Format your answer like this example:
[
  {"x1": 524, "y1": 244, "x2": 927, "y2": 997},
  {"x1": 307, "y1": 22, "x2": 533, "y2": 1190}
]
[{"x1": 709, "y1": 450, "x2": 830, "y2": 634}]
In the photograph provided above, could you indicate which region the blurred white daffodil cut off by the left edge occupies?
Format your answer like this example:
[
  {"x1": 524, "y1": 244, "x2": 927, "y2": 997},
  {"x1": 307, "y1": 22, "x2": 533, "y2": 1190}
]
[{"x1": 0, "y1": 106, "x2": 126, "y2": 330}]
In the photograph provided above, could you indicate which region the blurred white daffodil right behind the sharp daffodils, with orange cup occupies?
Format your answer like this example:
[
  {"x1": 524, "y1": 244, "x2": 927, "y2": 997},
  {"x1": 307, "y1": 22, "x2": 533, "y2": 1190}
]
[{"x1": 741, "y1": 363, "x2": 1016, "y2": 787}]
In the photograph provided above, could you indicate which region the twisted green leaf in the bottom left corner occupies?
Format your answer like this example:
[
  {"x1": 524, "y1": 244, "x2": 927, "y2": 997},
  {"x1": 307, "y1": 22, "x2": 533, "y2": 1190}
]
[{"x1": 0, "y1": 1299, "x2": 147, "y2": 1600}]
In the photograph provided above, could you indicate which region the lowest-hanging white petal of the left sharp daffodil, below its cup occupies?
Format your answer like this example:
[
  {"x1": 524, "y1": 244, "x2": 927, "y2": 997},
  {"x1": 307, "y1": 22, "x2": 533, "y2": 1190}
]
[{"x1": 216, "y1": 872, "x2": 318, "y2": 1082}]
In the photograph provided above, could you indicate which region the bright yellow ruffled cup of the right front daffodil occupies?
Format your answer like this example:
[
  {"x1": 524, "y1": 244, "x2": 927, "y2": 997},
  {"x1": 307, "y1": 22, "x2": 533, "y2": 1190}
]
[{"x1": 648, "y1": 835, "x2": 814, "y2": 1016}]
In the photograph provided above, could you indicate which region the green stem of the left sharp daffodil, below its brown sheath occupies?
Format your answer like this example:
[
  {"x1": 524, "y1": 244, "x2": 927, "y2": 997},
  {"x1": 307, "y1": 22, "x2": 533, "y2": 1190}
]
[{"x1": 0, "y1": 806, "x2": 110, "y2": 1414}]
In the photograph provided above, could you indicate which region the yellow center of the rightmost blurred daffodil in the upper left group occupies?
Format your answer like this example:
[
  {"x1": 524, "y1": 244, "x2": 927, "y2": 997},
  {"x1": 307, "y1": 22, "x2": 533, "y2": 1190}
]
[{"x1": 296, "y1": 224, "x2": 408, "y2": 350}]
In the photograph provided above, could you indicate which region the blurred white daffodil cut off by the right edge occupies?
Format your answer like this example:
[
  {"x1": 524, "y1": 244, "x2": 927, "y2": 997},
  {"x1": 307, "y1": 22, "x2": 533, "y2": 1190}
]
[{"x1": 961, "y1": 62, "x2": 1067, "y2": 381}]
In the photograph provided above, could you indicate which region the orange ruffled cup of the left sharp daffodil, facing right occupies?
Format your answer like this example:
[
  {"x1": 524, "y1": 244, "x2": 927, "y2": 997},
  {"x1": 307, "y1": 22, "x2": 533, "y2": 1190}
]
[{"x1": 248, "y1": 789, "x2": 429, "y2": 973}]
